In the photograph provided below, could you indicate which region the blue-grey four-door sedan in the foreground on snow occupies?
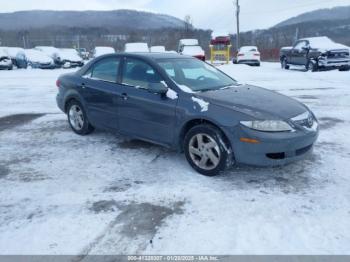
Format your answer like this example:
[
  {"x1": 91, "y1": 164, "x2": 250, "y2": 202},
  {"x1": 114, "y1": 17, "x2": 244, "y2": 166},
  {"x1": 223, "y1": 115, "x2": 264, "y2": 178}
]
[{"x1": 57, "y1": 53, "x2": 318, "y2": 176}]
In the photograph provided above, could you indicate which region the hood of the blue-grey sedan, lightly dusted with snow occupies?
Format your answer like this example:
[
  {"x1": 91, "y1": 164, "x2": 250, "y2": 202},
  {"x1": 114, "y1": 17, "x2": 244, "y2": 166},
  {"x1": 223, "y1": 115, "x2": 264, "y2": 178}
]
[{"x1": 195, "y1": 85, "x2": 307, "y2": 120}]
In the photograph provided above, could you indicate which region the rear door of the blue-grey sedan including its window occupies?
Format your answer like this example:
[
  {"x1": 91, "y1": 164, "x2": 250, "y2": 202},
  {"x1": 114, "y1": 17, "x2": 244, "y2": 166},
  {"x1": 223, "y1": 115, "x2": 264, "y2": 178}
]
[{"x1": 80, "y1": 57, "x2": 121, "y2": 129}]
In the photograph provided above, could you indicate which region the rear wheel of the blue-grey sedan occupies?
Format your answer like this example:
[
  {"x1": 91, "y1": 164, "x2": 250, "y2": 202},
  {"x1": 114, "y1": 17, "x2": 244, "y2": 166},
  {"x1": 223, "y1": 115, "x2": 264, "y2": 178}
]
[{"x1": 67, "y1": 100, "x2": 94, "y2": 136}]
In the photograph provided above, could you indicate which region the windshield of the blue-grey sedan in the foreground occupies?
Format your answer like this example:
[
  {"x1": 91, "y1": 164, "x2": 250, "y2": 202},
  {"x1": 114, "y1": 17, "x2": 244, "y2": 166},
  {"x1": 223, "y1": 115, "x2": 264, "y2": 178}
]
[{"x1": 158, "y1": 58, "x2": 238, "y2": 92}]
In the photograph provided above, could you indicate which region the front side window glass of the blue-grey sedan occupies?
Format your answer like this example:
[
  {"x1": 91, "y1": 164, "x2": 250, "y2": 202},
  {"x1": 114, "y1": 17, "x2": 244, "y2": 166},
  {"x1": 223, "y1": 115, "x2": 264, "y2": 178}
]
[{"x1": 122, "y1": 58, "x2": 162, "y2": 89}]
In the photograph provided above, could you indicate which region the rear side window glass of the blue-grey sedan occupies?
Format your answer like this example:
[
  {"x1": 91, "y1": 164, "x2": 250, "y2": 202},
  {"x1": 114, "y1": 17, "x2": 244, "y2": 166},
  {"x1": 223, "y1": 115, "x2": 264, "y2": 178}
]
[{"x1": 84, "y1": 57, "x2": 120, "y2": 83}]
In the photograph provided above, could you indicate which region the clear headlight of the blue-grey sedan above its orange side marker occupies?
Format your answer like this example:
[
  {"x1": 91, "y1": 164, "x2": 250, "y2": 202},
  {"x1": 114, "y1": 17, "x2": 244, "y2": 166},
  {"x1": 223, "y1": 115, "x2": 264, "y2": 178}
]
[{"x1": 241, "y1": 120, "x2": 293, "y2": 132}]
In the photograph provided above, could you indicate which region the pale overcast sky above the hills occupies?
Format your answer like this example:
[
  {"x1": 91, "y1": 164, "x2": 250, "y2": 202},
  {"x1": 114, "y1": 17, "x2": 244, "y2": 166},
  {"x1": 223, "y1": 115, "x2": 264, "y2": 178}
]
[{"x1": 0, "y1": 0, "x2": 350, "y2": 33}]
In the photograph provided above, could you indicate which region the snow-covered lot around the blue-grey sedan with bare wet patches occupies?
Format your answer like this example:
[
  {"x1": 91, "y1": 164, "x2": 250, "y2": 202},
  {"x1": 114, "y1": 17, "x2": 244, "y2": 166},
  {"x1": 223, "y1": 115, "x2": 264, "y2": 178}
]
[{"x1": 0, "y1": 63, "x2": 350, "y2": 255}]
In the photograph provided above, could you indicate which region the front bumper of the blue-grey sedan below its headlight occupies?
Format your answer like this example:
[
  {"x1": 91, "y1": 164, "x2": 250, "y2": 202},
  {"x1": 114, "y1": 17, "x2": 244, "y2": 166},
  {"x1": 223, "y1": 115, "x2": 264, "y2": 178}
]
[{"x1": 230, "y1": 125, "x2": 319, "y2": 166}]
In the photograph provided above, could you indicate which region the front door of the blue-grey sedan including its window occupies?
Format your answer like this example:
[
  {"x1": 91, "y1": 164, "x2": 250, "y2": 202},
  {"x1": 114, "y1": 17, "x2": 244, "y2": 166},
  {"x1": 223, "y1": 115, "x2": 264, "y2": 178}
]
[{"x1": 118, "y1": 57, "x2": 178, "y2": 145}]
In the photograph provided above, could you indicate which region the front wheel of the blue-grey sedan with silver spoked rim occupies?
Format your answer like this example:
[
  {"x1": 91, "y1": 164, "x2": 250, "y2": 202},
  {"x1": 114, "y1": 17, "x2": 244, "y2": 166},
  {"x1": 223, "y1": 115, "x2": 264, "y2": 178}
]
[{"x1": 184, "y1": 124, "x2": 233, "y2": 176}]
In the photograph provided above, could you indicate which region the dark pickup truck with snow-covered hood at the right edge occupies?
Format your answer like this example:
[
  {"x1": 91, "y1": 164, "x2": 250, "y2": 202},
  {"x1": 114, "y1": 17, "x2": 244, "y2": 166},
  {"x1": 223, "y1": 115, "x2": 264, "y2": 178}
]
[{"x1": 280, "y1": 36, "x2": 350, "y2": 72}]
